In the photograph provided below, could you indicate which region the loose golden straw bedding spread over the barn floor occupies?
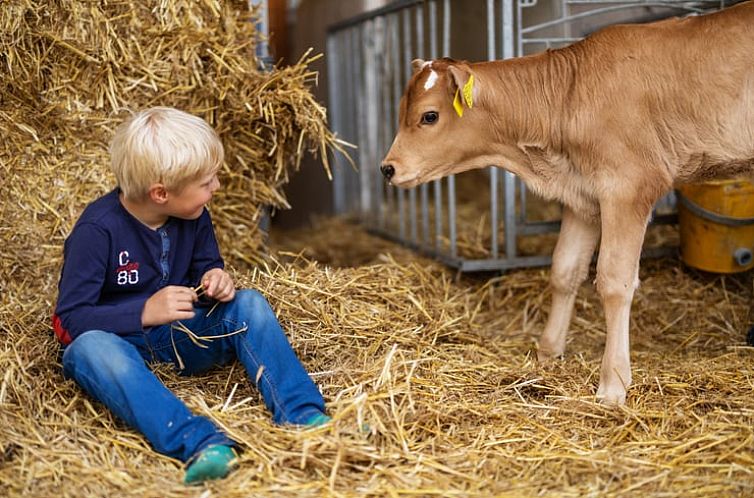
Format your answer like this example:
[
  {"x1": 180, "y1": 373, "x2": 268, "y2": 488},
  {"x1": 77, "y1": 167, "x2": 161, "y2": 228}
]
[{"x1": 0, "y1": 222, "x2": 754, "y2": 497}]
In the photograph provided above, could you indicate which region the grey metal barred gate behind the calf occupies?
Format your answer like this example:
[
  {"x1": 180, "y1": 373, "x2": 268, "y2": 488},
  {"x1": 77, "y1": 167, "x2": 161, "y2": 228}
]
[{"x1": 327, "y1": 0, "x2": 737, "y2": 271}]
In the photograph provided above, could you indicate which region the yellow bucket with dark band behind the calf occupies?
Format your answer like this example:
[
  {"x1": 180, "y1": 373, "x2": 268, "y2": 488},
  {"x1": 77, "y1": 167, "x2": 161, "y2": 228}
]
[{"x1": 678, "y1": 180, "x2": 754, "y2": 273}]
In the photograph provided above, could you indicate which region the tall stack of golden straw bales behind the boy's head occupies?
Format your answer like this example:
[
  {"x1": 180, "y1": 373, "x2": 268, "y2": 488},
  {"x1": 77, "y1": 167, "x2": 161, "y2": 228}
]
[{"x1": 0, "y1": 0, "x2": 337, "y2": 284}]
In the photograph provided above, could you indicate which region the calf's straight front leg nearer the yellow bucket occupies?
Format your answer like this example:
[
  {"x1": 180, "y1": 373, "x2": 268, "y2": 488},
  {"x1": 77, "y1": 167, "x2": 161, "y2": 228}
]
[{"x1": 597, "y1": 200, "x2": 649, "y2": 405}]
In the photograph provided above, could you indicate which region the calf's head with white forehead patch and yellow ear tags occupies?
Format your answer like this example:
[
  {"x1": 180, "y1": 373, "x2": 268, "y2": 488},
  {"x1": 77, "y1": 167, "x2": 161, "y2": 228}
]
[{"x1": 380, "y1": 59, "x2": 484, "y2": 187}]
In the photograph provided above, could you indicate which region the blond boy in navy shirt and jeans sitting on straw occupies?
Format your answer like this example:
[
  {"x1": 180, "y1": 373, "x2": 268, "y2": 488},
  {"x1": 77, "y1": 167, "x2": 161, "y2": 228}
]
[{"x1": 53, "y1": 107, "x2": 329, "y2": 483}]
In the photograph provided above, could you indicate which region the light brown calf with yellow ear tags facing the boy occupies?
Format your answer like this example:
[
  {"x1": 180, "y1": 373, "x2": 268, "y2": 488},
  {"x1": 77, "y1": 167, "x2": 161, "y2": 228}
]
[{"x1": 381, "y1": 2, "x2": 754, "y2": 404}]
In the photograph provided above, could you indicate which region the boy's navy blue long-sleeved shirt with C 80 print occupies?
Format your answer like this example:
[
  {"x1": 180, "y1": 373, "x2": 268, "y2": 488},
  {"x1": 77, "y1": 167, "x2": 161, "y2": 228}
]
[{"x1": 53, "y1": 189, "x2": 224, "y2": 344}]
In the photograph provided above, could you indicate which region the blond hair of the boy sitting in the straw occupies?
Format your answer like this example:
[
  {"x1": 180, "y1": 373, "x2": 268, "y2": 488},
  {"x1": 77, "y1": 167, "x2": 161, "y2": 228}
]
[{"x1": 110, "y1": 107, "x2": 224, "y2": 200}]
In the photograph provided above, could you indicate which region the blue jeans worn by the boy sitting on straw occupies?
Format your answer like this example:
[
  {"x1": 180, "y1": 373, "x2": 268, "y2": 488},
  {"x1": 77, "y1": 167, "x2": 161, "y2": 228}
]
[{"x1": 63, "y1": 290, "x2": 325, "y2": 462}]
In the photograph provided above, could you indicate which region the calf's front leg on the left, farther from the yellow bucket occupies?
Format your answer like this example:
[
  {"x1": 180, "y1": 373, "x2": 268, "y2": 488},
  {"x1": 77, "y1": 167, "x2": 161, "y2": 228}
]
[{"x1": 537, "y1": 207, "x2": 600, "y2": 361}]
